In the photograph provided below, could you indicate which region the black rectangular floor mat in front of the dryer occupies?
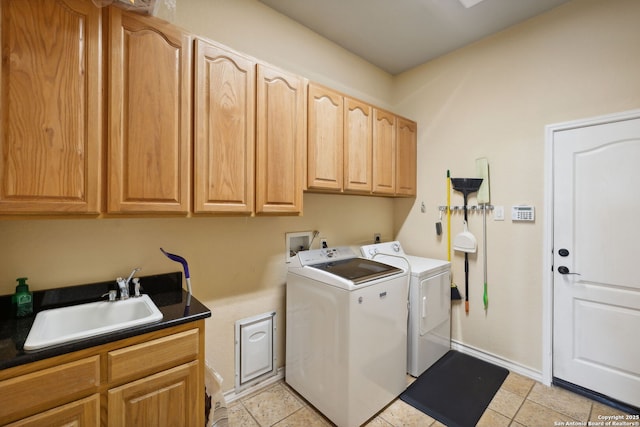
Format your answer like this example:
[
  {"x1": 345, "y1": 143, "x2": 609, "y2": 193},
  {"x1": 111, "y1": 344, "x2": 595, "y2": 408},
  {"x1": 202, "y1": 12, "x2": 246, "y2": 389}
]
[{"x1": 400, "y1": 350, "x2": 509, "y2": 427}]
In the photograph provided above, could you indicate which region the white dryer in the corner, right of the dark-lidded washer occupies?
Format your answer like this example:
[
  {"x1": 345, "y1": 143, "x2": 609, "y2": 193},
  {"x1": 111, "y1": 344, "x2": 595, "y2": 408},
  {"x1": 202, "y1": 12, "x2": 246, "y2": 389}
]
[{"x1": 360, "y1": 241, "x2": 451, "y2": 377}]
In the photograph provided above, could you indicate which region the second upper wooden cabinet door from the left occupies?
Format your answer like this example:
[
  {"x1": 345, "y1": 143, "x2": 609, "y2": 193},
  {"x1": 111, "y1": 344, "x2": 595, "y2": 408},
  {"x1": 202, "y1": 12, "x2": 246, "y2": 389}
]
[{"x1": 108, "y1": 7, "x2": 193, "y2": 213}]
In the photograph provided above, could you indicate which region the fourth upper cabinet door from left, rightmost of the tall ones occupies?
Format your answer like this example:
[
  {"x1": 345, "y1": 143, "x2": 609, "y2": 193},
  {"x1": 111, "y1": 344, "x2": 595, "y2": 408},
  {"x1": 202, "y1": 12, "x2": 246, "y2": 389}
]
[{"x1": 256, "y1": 64, "x2": 307, "y2": 214}]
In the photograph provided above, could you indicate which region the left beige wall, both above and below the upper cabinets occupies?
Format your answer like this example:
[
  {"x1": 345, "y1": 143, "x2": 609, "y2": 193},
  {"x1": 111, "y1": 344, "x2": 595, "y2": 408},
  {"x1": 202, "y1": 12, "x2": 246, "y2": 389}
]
[{"x1": 0, "y1": 0, "x2": 393, "y2": 391}]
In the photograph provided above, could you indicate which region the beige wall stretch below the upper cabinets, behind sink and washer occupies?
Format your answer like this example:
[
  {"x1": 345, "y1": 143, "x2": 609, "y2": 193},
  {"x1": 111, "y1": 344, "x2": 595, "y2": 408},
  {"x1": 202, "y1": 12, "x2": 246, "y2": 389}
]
[{"x1": 0, "y1": 194, "x2": 393, "y2": 390}]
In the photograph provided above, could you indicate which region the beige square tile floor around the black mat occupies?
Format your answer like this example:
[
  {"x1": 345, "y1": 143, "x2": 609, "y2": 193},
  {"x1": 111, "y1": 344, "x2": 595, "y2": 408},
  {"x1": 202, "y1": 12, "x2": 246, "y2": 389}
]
[{"x1": 227, "y1": 373, "x2": 636, "y2": 427}]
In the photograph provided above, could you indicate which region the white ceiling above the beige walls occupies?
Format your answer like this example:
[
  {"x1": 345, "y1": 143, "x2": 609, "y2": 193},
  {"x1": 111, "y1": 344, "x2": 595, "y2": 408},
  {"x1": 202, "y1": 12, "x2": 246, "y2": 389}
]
[{"x1": 260, "y1": 0, "x2": 568, "y2": 75}]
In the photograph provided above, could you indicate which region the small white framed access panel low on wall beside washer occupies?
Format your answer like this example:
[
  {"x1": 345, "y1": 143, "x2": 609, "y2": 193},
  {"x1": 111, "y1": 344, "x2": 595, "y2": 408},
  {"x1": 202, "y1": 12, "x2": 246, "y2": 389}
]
[{"x1": 235, "y1": 311, "x2": 276, "y2": 393}]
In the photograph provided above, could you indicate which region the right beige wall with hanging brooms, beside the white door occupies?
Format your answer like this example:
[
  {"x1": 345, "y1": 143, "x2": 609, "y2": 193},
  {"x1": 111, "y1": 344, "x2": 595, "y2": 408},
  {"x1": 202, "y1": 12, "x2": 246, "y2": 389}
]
[{"x1": 393, "y1": 0, "x2": 640, "y2": 373}]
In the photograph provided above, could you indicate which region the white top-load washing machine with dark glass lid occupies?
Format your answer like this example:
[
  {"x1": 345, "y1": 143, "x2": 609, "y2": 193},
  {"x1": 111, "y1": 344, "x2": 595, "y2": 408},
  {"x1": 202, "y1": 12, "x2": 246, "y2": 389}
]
[{"x1": 285, "y1": 247, "x2": 409, "y2": 427}]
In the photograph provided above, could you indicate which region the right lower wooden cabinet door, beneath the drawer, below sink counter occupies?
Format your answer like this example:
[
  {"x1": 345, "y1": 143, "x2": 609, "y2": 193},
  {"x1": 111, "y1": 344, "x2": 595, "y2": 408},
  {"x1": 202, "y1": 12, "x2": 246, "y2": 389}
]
[{"x1": 107, "y1": 361, "x2": 198, "y2": 427}]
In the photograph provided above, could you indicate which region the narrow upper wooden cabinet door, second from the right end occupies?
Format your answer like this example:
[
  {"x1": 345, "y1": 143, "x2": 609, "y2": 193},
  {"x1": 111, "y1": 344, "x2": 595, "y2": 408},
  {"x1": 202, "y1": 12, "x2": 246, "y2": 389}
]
[{"x1": 373, "y1": 108, "x2": 396, "y2": 195}]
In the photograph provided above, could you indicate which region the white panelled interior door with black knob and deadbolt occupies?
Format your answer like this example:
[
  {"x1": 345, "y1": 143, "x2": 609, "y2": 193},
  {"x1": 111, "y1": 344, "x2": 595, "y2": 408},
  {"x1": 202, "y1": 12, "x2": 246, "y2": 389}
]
[{"x1": 553, "y1": 114, "x2": 640, "y2": 407}]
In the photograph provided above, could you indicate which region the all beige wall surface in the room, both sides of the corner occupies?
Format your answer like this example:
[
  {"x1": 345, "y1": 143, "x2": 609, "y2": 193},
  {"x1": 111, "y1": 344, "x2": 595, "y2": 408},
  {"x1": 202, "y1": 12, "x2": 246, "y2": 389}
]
[{"x1": 0, "y1": 0, "x2": 640, "y2": 390}]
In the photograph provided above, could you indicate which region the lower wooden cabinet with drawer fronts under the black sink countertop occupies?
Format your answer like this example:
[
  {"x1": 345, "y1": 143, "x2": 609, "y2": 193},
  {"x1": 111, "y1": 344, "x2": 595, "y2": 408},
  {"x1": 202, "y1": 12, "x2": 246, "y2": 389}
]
[{"x1": 0, "y1": 320, "x2": 205, "y2": 427}]
